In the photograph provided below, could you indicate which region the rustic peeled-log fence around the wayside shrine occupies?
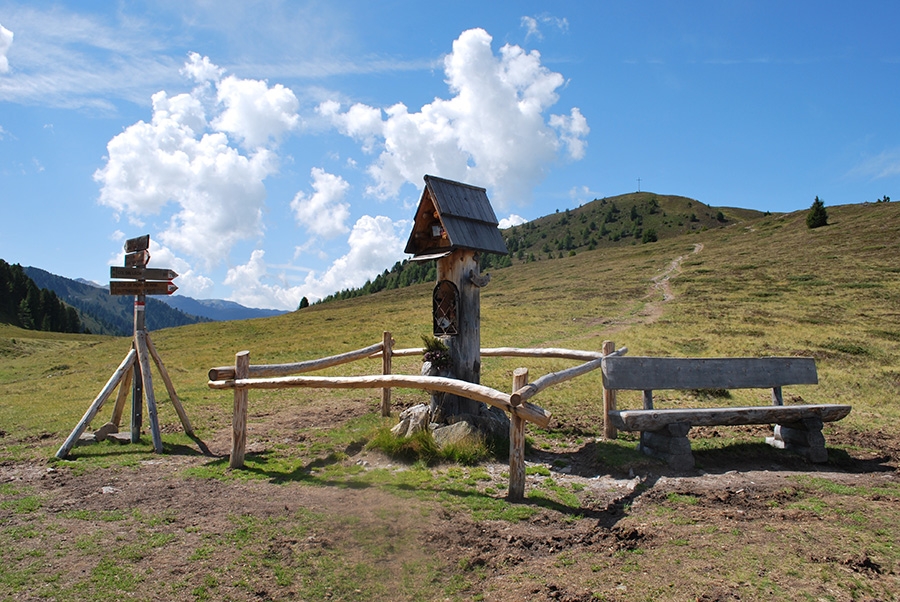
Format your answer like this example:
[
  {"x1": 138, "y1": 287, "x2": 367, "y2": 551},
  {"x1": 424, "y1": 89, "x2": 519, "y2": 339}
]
[{"x1": 208, "y1": 332, "x2": 627, "y2": 501}]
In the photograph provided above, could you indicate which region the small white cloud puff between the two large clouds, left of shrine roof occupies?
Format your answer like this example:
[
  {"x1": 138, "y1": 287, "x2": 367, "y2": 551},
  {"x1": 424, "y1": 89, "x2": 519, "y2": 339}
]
[{"x1": 291, "y1": 167, "x2": 350, "y2": 238}]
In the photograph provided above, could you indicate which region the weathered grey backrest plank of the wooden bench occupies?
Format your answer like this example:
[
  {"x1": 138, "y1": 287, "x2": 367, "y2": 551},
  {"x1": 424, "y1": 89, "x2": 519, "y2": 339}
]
[{"x1": 602, "y1": 356, "x2": 819, "y2": 391}]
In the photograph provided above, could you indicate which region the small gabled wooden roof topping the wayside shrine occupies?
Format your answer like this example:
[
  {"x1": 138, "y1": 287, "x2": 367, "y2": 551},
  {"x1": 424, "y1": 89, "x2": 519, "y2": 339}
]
[{"x1": 406, "y1": 176, "x2": 509, "y2": 260}]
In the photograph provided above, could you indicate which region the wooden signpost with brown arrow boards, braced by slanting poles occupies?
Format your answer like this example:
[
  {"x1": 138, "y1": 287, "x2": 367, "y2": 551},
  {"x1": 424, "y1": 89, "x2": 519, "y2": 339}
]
[{"x1": 56, "y1": 234, "x2": 194, "y2": 458}]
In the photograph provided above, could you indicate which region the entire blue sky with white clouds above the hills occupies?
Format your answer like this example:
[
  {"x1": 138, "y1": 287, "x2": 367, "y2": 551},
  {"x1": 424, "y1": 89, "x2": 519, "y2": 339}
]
[{"x1": 0, "y1": 0, "x2": 900, "y2": 309}]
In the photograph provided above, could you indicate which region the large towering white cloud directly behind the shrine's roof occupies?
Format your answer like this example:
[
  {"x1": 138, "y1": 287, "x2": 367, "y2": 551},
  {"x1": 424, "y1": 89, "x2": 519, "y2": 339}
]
[{"x1": 318, "y1": 29, "x2": 589, "y2": 206}]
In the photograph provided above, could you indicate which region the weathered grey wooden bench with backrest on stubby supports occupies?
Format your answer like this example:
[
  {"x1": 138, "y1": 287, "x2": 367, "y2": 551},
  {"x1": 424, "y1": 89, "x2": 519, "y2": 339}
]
[{"x1": 602, "y1": 356, "x2": 851, "y2": 470}]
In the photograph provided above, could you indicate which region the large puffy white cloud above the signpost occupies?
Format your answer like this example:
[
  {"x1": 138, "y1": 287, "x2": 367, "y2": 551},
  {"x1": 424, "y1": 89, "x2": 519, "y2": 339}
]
[{"x1": 94, "y1": 55, "x2": 297, "y2": 268}]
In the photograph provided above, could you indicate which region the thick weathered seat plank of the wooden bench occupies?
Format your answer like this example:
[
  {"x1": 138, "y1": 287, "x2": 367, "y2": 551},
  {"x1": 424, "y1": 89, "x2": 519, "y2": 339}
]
[{"x1": 609, "y1": 404, "x2": 851, "y2": 431}]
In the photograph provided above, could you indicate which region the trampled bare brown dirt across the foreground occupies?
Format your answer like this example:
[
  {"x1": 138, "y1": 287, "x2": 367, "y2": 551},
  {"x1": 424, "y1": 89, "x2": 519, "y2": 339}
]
[{"x1": 0, "y1": 400, "x2": 900, "y2": 601}]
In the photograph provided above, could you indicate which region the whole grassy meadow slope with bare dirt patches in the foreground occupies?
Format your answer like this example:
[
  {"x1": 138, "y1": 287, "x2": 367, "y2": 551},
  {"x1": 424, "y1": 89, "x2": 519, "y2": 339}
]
[{"x1": 0, "y1": 201, "x2": 900, "y2": 600}]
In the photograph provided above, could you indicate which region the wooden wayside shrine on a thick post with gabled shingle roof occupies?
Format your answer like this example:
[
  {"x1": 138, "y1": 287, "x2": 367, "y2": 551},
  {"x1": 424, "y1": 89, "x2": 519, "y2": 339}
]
[{"x1": 406, "y1": 175, "x2": 508, "y2": 418}]
